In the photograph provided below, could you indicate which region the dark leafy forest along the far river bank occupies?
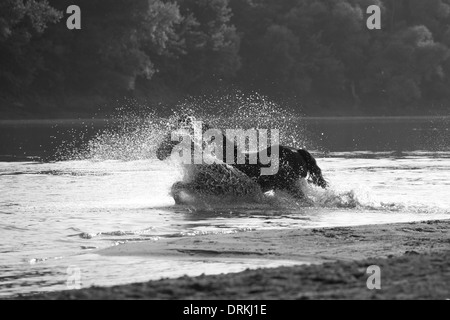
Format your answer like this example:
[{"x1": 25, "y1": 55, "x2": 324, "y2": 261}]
[{"x1": 0, "y1": 0, "x2": 450, "y2": 119}]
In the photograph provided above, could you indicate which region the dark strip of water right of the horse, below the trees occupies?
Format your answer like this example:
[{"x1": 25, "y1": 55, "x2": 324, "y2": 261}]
[{"x1": 306, "y1": 117, "x2": 450, "y2": 152}]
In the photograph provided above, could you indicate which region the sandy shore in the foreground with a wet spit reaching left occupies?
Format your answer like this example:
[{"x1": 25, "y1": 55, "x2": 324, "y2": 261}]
[{"x1": 11, "y1": 220, "x2": 450, "y2": 300}]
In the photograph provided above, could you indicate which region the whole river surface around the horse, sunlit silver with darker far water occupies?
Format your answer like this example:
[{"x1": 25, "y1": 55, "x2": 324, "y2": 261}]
[{"x1": 0, "y1": 119, "x2": 450, "y2": 296}]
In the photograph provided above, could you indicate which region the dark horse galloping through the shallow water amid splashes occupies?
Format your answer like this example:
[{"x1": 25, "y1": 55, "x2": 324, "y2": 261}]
[{"x1": 156, "y1": 117, "x2": 328, "y2": 199}]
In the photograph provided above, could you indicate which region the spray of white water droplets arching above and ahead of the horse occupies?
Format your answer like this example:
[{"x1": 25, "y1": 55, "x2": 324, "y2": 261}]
[{"x1": 57, "y1": 95, "x2": 307, "y2": 161}]
